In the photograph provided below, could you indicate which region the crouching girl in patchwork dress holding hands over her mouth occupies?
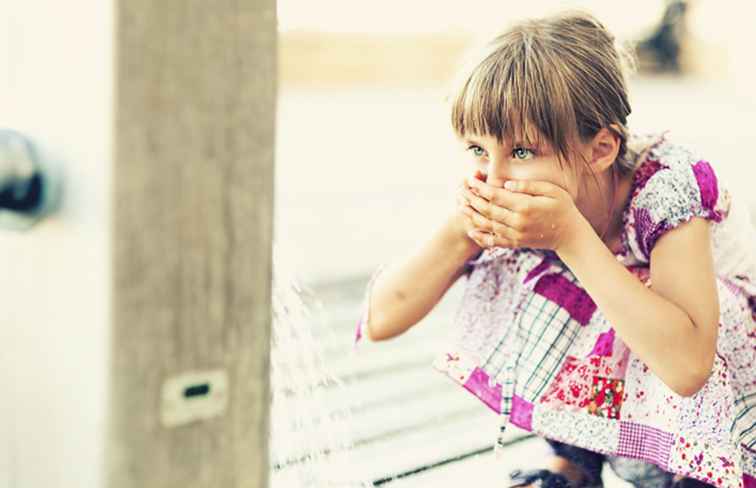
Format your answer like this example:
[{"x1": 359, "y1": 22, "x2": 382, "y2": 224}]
[{"x1": 357, "y1": 14, "x2": 756, "y2": 488}]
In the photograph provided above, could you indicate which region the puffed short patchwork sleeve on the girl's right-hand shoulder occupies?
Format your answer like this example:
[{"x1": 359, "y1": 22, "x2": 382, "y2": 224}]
[{"x1": 629, "y1": 148, "x2": 727, "y2": 262}]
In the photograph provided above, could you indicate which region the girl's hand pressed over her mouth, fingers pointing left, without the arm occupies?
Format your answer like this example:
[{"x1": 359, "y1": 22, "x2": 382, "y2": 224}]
[{"x1": 464, "y1": 178, "x2": 583, "y2": 251}]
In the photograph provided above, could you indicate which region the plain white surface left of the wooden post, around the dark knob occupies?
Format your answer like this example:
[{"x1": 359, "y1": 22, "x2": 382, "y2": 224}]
[{"x1": 0, "y1": 0, "x2": 113, "y2": 487}]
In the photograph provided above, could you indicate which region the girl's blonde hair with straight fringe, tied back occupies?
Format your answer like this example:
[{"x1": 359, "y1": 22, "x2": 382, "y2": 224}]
[{"x1": 450, "y1": 12, "x2": 634, "y2": 173}]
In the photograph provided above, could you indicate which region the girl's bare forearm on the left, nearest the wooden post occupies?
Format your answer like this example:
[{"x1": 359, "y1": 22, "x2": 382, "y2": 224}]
[{"x1": 365, "y1": 213, "x2": 481, "y2": 341}]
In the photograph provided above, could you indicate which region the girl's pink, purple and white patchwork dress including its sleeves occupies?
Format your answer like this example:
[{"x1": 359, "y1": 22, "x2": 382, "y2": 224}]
[{"x1": 356, "y1": 135, "x2": 756, "y2": 488}]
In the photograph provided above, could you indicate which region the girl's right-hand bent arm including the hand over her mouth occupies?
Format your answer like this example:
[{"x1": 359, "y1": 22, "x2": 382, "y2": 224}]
[{"x1": 470, "y1": 177, "x2": 719, "y2": 396}]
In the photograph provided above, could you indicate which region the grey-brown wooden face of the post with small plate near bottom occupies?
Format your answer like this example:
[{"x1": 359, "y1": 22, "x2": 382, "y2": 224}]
[{"x1": 106, "y1": 0, "x2": 276, "y2": 488}]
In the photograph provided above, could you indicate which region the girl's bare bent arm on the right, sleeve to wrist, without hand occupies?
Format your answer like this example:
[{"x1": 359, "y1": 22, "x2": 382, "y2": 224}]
[{"x1": 557, "y1": 212, "x2": 719, "y2": 396}]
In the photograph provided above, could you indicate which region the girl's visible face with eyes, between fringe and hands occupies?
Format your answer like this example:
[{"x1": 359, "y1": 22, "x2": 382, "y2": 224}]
[{"x1": 463, "y1": 132, "x2": 579, "y2": 200}]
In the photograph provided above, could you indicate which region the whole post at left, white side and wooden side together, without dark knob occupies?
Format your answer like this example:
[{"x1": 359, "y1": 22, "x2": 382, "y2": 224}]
[{"x1": 0, "y1": 0, "x2": 276, "y2": 488}]
